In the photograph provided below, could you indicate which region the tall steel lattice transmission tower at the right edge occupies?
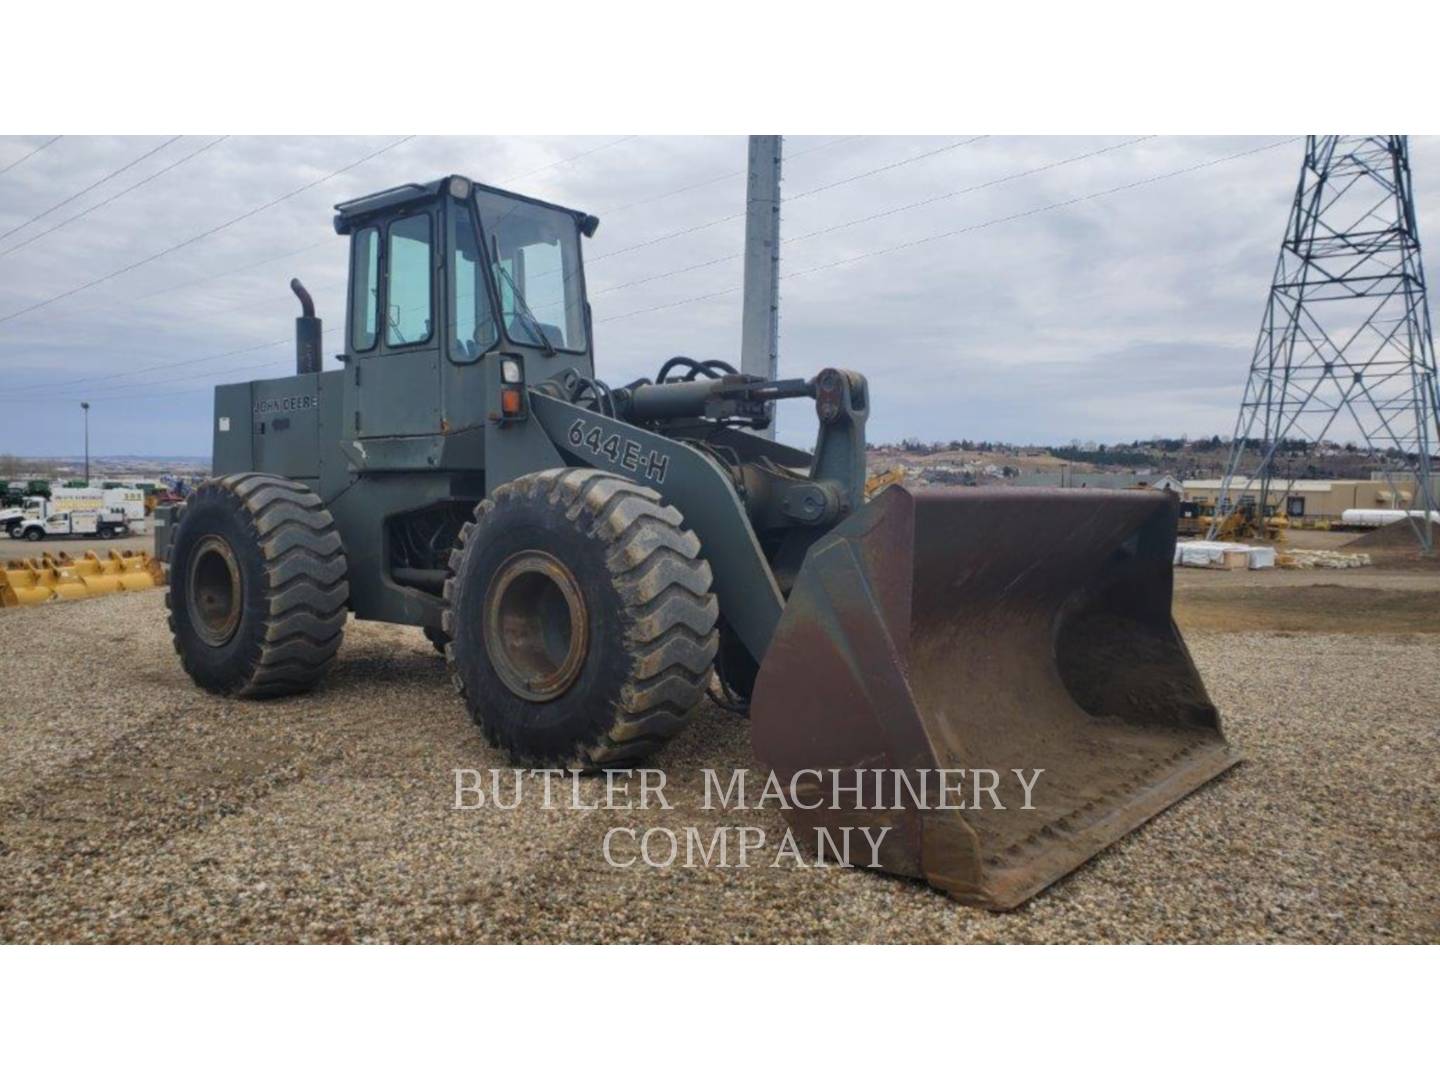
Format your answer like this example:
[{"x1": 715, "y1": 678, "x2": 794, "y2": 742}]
[{"x1": 1211, "y1": 135, "x2": 1440, "y2": 552}]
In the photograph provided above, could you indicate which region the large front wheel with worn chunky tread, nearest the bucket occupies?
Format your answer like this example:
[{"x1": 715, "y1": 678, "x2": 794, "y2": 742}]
[{"x1": 444, "y1": 468, "x2": 719, "y2": 770}]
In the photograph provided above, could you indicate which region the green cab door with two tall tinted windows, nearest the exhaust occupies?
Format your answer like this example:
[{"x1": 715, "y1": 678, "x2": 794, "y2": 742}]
[{"x1": 346, "y1": 207, "x2": 441, "y2": 439}]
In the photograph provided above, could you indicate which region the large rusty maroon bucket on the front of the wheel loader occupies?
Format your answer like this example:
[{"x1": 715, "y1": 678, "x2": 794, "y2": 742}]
[{"x1": 750, "y1": 487, "x2": 1240, "y2": 910}]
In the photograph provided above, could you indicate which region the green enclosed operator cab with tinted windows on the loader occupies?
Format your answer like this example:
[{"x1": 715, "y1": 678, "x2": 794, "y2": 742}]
[{"x1": 329, "y1": 176, "x2": 599, "y2": 449}]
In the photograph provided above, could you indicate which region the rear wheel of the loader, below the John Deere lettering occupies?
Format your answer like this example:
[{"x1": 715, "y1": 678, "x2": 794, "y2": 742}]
[{"x1": 166, "y1": 472, "x2": 350, "y2": 697}]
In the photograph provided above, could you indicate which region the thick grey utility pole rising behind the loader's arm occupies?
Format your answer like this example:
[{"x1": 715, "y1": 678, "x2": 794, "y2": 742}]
[{"x1": 740, "y1": 135, "x2": 780, "y2": 438}]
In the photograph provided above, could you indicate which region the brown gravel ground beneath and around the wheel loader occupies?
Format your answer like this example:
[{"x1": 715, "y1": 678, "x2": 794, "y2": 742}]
[{"x1": 0, "y1": 587, "x2": 1440, "y2": 942}]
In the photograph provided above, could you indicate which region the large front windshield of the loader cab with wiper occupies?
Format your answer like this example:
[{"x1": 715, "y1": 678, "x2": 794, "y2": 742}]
[{"x1": 475, "y1": 192, "x2": 586, "y2": 353}]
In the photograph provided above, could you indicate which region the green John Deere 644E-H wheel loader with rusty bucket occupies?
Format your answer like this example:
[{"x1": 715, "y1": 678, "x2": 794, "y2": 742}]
[{"x1": 157, "y1": 176, "x2": 1237, "y2": 909}]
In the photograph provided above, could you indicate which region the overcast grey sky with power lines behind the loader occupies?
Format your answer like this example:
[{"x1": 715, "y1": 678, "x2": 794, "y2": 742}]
[{"x1": 0, "y1": 135, "x2": 1440, "y2": 455}]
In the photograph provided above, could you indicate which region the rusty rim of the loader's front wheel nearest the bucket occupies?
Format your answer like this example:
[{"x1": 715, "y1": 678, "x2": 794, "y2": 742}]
[{"x1": 485, "y1": 552, "x2": 589, "y2": 701}]
